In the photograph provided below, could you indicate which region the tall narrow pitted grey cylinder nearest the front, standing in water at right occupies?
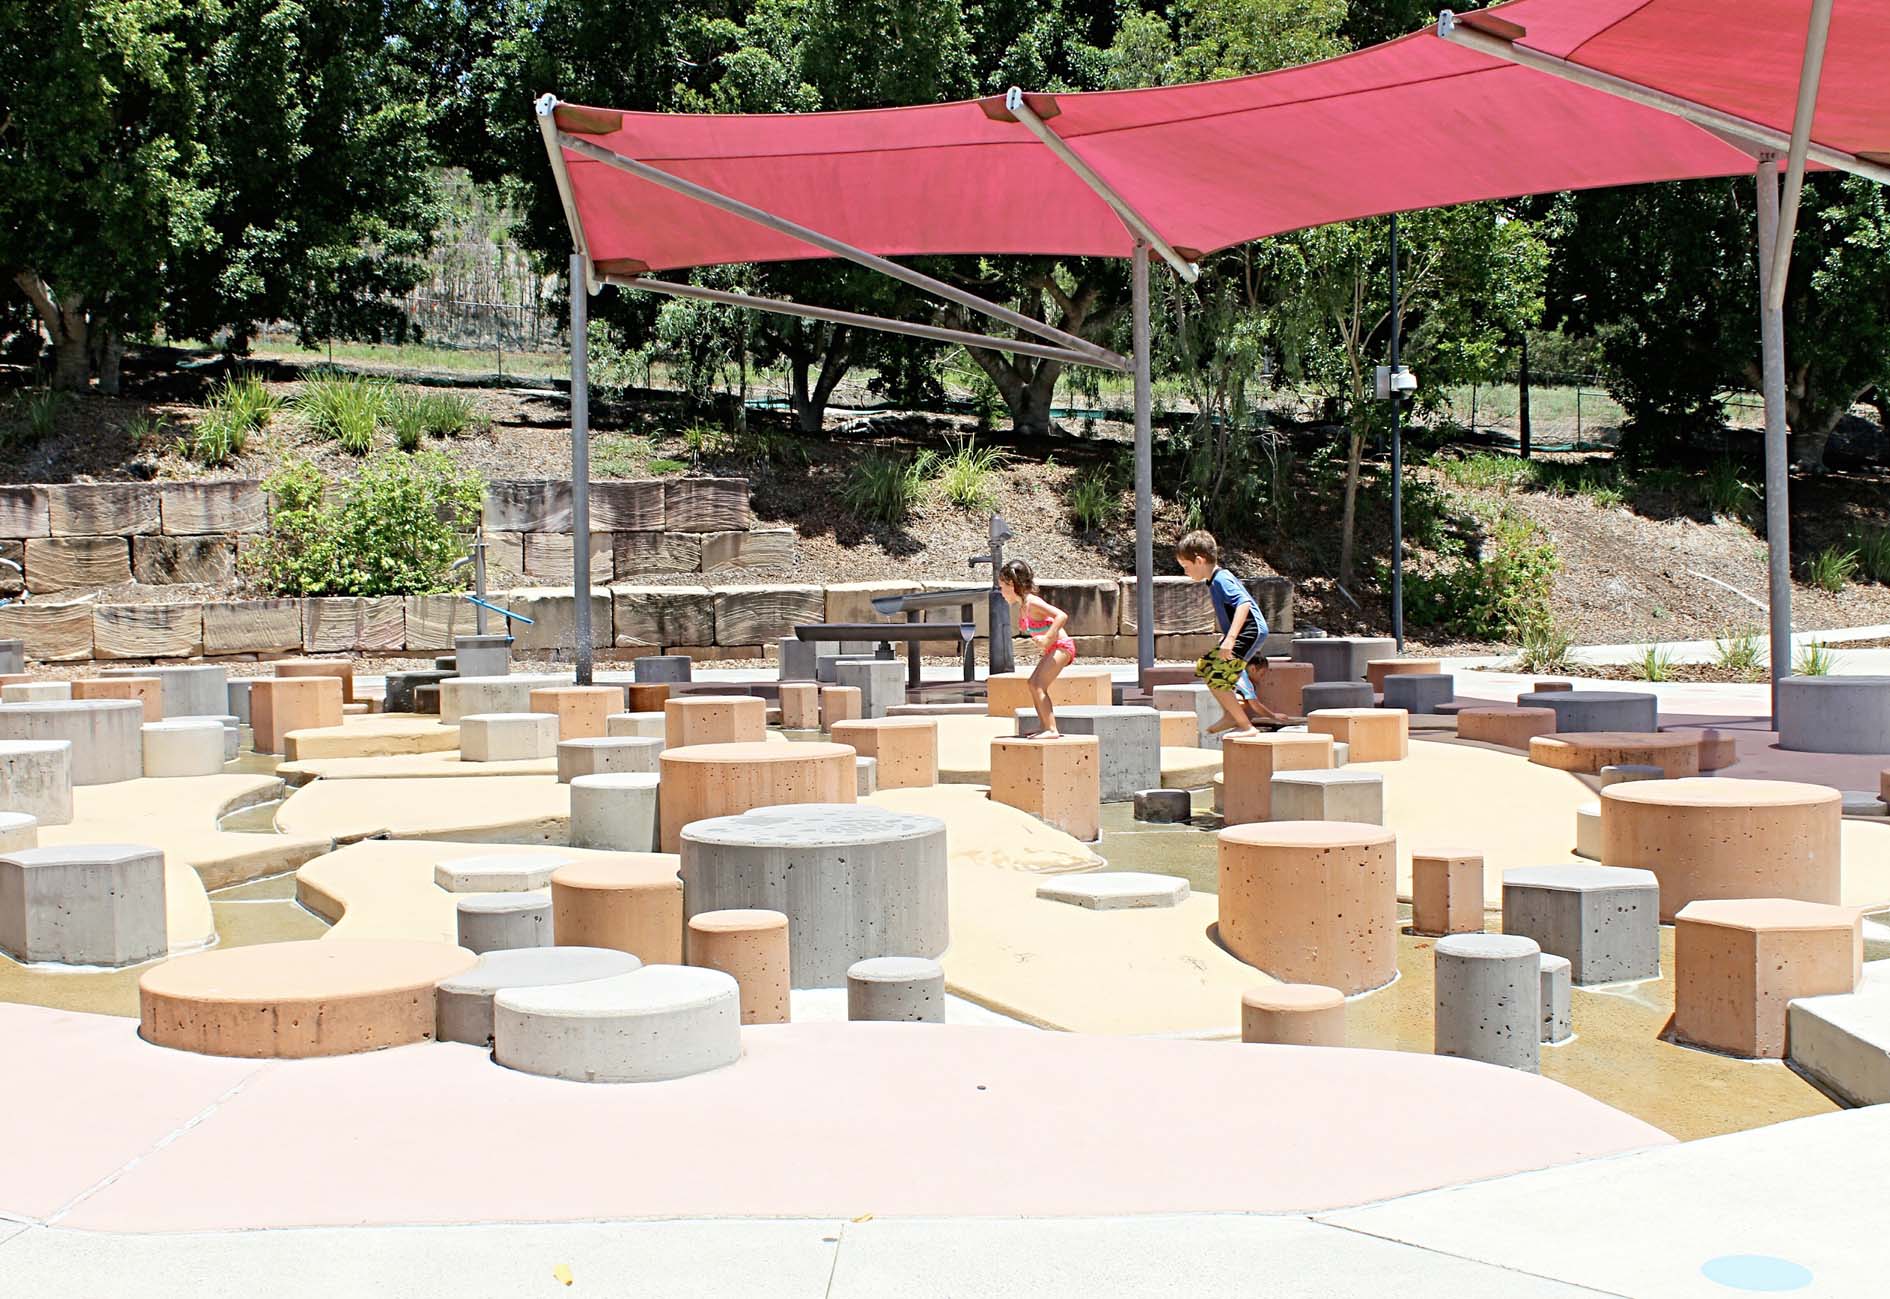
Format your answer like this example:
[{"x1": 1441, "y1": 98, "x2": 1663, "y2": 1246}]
[{"x1": 1435, "y1": 934, "x2": 1542, "y2": 1074}]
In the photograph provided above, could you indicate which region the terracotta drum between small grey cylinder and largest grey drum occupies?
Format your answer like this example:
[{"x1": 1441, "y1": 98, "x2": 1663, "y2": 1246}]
[{"x1": 552, "y1": 853, "x2": 682, "y2": 964}]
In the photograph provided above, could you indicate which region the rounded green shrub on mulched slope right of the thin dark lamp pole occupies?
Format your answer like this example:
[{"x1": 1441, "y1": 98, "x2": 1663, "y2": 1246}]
[{"x1": 1404, "y1": 509, "x2": 1561, "y2": 641}]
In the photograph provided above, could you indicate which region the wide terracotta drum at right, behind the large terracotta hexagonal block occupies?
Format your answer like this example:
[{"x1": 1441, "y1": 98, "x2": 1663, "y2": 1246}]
[{"x1": 1601, "y1": 777, "x2": 1843, "y2": 923}]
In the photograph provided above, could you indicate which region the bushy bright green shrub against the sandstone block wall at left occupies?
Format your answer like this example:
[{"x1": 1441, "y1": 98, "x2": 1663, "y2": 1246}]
[{"x1": 249, "y1": 452, "x2": 484, "y2": 596}]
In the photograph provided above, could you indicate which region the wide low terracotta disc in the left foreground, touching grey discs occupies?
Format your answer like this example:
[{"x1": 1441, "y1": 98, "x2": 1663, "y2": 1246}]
[{"x1": 138, "y1": 938, "x2": 476, "y2": 1059}]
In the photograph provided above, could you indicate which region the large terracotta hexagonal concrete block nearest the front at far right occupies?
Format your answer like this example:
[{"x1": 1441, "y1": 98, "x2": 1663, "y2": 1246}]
[{"x1": 1673, "y1": 898, "x2": 1864, "y2": 1059}]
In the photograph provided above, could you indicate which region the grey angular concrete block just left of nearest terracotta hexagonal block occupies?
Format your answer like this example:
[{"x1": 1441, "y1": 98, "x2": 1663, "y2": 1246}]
[{"x1": 1503, "y1": 866, "x2": 1659, "y2": 985}]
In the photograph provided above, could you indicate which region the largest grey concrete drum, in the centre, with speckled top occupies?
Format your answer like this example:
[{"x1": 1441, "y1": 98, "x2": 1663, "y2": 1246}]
[{"x1": 680, "y1": 792, "x2": 949, "y2": 987}]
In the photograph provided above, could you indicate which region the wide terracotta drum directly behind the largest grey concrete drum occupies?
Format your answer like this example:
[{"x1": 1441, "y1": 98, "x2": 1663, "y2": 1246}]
[{"x1": 653, "y1": 743, "x2": 860, "y2": 854}]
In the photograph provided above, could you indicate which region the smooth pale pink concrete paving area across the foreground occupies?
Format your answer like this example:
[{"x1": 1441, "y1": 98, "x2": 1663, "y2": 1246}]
[{"x1": 0, "y1": 1008, "x2": 1671, "y2": 1231}]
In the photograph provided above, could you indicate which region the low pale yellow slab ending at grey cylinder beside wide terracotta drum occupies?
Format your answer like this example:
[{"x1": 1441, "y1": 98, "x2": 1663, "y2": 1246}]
[{"x1": 276, "y1": 775, "x2": 571, "y2": 843}]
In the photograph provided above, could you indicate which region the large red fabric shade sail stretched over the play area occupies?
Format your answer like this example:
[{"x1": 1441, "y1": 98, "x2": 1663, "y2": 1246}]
[{"x1": 540, "y1": 0, "x2": 1890, "y2": 270}]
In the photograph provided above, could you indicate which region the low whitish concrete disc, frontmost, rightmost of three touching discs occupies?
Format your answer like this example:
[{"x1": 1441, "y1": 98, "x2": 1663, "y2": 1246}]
[{"x1": 491, "y1": 964, "x2": 741, "y2": 1083}]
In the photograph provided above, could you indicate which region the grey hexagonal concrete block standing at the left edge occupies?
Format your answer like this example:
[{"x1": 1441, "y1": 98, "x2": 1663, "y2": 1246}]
[{"x1": 0, "y1": 843, "x2": 170, "y2": 966}]
